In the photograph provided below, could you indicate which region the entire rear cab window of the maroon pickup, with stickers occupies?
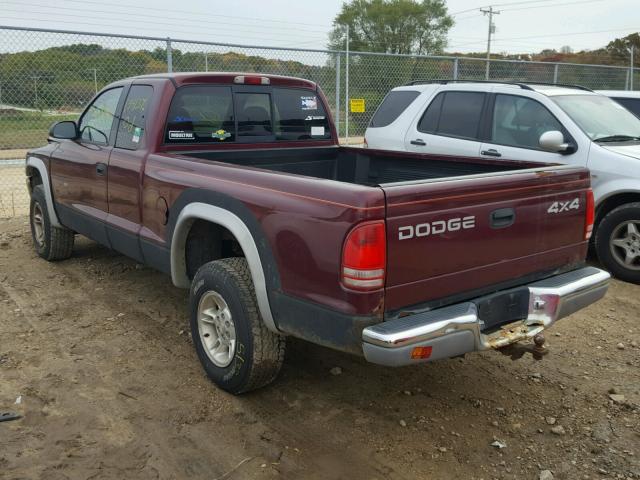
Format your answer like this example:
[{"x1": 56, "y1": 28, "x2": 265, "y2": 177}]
[{"x1": 165, "y1": 85, "x2": 331, "y2": 144}]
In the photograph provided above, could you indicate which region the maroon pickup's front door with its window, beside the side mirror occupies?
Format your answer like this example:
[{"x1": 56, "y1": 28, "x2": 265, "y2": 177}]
[{"x1": 51, "y1": 87, "x2": 123, "y2": 243}]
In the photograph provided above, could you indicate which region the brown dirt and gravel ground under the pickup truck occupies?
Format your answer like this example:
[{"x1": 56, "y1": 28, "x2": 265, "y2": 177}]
[{"x1": 0, "y1": 218, "x2": 640, "y2": 480}]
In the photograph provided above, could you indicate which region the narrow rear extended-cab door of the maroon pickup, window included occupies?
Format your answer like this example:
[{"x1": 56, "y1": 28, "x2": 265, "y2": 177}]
[{"x1": 107, "y1": 85, "x2": 153, "y2": 261}]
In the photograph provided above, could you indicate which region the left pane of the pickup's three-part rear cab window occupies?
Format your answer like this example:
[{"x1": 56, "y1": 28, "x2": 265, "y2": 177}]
[{"x1": 165, "y1": 85, "x2": 236, "y2": 143}]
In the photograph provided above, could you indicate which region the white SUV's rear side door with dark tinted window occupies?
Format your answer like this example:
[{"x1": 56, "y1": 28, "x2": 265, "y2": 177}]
[{"x1": 405, "y1": 90, "x2": 487, "y2": 157}]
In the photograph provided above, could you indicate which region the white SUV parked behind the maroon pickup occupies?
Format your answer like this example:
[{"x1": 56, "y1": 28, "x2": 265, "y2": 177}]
[{"x1": 365, "y1": 81, "x2": 640, "y2": 283}]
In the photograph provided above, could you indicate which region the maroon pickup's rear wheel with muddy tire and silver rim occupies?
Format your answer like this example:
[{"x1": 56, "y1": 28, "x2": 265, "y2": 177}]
[{"x1": 189, "y1": 257, "x2": 285, "y2": 395}]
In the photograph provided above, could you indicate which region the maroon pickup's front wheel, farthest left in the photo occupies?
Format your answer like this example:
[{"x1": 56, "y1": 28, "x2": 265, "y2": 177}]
[{"x1": 29, "y1": 185, "x2": 75, "y2": 261}]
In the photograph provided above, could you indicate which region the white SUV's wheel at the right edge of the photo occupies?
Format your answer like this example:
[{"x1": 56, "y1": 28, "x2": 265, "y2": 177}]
[{"x1": 596, "y1": 202, "x2": 640, "y2": 283}]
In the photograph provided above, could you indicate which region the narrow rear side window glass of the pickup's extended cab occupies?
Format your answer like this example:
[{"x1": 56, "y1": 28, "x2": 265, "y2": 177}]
[{"x1": 115, "y1": 85, "x2": 153, "y2": 150}]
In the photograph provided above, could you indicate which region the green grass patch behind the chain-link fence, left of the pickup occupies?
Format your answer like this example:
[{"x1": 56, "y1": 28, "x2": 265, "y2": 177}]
[{"x1": 0, "y1": 109, "x2": 78, "y2": 150}]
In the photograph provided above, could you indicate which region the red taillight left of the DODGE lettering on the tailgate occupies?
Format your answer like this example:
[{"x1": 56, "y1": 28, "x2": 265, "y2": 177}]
[{"x1": 342, "y1": 221, "x2": 387, "y2": 290}]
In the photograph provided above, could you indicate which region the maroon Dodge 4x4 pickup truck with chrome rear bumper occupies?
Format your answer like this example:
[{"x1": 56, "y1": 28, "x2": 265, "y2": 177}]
[{"x1": 26, "y1": 73, "x2": 609, "y2": 393}]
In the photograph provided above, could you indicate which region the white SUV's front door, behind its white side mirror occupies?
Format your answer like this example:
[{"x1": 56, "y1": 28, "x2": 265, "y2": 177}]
[{"x1": 480, "y1": 93, "x2": 575, "y2": 163}]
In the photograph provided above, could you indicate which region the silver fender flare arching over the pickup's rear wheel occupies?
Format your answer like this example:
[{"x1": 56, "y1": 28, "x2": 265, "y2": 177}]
[{"x1": 171, "y1": 202, "x2": 281, "y2": 333}]
